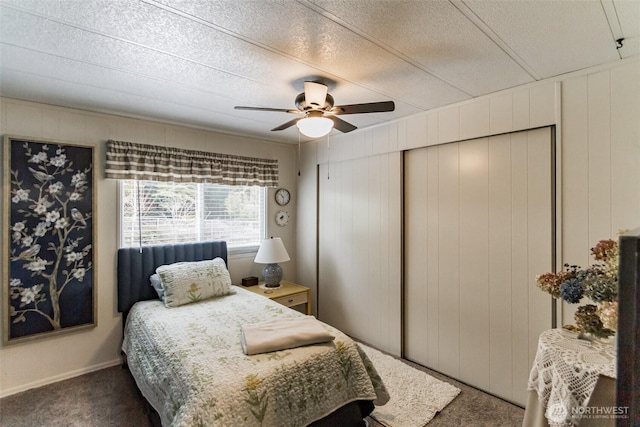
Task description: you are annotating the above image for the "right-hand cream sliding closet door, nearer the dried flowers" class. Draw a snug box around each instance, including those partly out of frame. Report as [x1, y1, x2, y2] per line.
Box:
[404, 128, 554, 405]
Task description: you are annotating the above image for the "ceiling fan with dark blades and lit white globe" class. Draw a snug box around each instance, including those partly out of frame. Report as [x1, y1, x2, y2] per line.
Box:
[235, 82, 395, 138]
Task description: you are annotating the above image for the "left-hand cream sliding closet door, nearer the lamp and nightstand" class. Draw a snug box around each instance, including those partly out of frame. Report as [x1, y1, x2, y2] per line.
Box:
[318, 153, 402, 351]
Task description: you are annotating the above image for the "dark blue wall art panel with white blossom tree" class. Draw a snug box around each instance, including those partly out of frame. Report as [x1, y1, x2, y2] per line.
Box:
[2, 136, 96, 344]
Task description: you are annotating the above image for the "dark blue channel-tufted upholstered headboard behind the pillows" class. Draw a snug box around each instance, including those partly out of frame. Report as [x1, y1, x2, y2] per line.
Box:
[118, 241, 228, 314]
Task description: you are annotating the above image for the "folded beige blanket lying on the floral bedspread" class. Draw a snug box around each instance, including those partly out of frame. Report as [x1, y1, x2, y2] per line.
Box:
[240, 316, 334, 355]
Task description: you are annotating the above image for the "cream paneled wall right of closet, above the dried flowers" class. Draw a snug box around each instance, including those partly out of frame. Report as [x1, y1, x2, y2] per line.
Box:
[561, 61, 640, 324]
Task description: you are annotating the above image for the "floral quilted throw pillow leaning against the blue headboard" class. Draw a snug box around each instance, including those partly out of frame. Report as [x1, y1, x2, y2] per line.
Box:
[156, 258, 235, 307]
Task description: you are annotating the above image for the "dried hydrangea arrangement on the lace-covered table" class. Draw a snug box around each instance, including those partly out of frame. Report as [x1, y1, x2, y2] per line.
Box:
[536, 239, 619, 338]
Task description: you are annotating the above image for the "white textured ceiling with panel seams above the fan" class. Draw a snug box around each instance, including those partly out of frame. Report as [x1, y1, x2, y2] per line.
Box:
[0, 0, 640, 142]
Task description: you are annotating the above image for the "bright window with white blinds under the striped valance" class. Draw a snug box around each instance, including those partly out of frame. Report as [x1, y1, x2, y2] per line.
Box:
[120, 180, 266, 249]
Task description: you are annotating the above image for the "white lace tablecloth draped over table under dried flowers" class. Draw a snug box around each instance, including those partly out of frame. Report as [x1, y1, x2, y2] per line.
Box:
[528, 329, 616, 427]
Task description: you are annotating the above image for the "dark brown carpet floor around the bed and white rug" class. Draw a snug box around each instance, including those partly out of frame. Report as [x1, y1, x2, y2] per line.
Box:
[0, 362, 524, 427]
